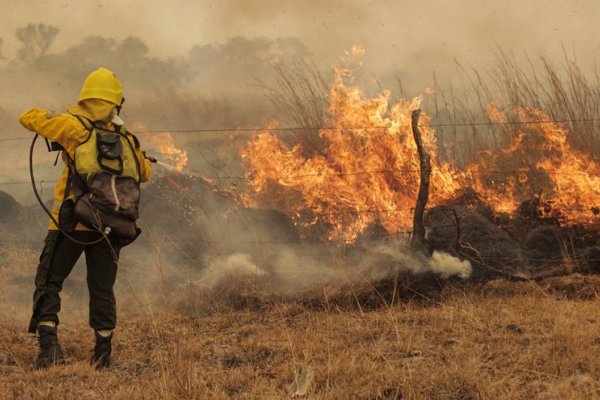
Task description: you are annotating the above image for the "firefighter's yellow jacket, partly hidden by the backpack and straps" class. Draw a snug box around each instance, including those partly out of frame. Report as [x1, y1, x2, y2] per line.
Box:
[19, 99, 152, 231]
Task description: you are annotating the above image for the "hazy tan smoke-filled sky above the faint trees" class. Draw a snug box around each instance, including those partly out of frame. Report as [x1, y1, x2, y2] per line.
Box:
[0, 0, 600, 77]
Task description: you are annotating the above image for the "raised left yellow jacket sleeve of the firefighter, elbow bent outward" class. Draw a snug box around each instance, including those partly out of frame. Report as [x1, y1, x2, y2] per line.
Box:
[19, 108, 83, 149]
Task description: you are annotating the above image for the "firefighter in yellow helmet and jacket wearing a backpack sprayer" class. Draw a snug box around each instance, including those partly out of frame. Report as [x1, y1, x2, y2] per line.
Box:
[20, 68, 151, 369]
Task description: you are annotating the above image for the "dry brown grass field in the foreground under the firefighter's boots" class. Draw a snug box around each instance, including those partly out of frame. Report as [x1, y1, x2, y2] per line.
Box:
[0, 245, 600, 399]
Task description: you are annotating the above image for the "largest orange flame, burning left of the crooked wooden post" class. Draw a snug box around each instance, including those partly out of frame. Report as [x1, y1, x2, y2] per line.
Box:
[242, 69, 459, 241]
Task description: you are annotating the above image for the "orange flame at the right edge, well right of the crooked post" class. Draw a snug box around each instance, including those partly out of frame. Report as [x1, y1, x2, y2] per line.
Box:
[469, 107, 600, 225]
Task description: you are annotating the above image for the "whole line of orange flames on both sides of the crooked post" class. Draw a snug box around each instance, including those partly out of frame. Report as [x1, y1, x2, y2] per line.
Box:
[241, 68, 600, 241]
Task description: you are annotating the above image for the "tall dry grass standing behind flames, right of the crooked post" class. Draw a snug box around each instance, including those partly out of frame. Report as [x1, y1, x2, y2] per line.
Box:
[425, 49, 600, 166]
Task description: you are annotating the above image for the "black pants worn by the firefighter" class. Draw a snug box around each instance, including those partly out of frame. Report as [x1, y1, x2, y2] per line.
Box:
[29, 231, 120, 333]
